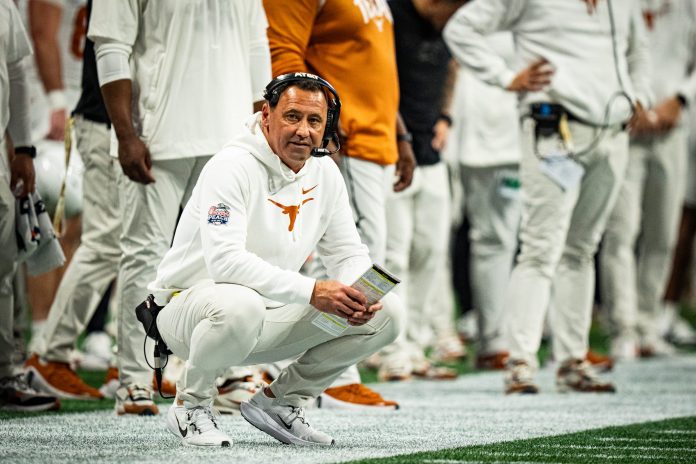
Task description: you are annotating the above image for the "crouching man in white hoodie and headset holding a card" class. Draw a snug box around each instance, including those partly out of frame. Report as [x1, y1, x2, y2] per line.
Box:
[150, 73, 404, 446]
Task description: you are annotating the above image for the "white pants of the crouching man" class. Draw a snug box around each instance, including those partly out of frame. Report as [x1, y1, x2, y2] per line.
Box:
[157, 283, 403, 406]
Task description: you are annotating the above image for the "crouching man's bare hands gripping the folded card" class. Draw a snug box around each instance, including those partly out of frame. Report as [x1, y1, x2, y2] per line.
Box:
[309, 280, 367, 320]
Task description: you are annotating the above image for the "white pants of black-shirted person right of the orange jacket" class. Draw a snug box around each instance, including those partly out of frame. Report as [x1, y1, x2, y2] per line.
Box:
[386, 163, 453, 356]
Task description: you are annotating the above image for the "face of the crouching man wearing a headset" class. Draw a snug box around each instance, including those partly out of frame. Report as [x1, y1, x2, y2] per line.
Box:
[261, 86, 327, 172]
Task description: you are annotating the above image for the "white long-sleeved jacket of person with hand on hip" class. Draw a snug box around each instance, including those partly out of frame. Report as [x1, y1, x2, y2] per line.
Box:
[444, 0, 652, 125]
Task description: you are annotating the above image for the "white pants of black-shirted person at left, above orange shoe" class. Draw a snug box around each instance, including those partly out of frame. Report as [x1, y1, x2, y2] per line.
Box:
[38, 116, 121, 362]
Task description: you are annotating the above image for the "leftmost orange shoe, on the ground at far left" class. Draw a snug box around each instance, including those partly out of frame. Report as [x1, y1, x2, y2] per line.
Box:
[24, 354, 104, 400]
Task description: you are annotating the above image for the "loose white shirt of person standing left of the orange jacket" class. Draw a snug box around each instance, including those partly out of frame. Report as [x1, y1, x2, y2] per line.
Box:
[88, 0, 271, 160]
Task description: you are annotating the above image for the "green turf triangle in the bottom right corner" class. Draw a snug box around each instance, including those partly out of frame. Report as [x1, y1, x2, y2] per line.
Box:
[351, 417, 696, 464]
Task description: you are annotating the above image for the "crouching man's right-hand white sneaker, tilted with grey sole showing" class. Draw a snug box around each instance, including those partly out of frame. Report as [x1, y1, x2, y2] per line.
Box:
[239, 389, 335, 446]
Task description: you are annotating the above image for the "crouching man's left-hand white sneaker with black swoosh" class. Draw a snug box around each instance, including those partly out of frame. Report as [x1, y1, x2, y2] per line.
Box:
[167, 404, 232, 447]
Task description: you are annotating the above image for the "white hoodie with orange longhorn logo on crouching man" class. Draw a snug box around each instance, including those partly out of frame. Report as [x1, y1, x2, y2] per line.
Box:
[149, 113, 372, 307]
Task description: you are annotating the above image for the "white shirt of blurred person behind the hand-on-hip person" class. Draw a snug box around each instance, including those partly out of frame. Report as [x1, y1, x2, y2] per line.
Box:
[446, 32, 520, 167]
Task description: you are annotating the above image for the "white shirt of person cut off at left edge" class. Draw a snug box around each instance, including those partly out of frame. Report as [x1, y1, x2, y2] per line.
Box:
[0, 0, 31, 141]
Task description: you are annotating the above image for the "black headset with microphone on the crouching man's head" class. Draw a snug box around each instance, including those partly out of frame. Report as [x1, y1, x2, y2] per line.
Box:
[263, 72, 341, 157]
